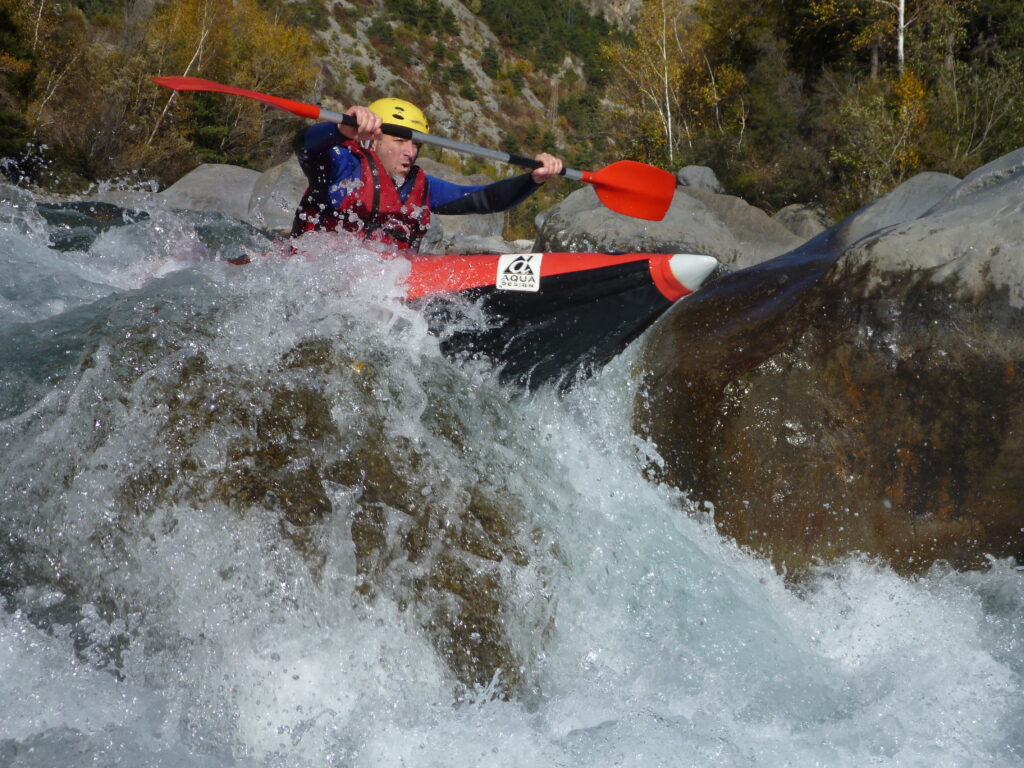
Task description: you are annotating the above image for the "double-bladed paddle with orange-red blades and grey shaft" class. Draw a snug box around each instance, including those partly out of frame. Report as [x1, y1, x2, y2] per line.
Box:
[153, 77, 676, 221]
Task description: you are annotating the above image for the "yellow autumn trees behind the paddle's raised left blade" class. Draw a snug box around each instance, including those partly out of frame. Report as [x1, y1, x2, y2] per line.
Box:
[0, 0, 318, 185]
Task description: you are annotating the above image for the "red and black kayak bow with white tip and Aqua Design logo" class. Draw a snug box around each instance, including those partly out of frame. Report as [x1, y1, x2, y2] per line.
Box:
[406, 253, 718, 389]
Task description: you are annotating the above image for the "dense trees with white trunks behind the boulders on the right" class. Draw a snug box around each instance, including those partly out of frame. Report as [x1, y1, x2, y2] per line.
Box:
[604, 0, 1024, 214]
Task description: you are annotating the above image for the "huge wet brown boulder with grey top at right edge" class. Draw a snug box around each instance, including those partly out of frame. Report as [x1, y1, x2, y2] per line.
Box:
[637, 153, 1024, 573]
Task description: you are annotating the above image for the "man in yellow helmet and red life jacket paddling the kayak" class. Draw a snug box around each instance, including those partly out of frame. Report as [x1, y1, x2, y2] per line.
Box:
[292, 98, 562, 250]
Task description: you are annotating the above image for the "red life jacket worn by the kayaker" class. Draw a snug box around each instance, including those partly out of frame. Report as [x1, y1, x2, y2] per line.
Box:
[292, 141, 430, 251]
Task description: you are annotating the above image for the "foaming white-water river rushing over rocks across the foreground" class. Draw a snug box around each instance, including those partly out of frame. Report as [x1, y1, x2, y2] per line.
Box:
[0, 186, 1024, 768]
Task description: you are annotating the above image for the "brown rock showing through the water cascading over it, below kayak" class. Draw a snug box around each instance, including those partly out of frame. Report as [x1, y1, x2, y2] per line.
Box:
[119, 337, 544, 695]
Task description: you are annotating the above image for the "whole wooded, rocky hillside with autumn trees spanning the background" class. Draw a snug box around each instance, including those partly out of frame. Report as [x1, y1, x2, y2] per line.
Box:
[0, 0, 1024, 228]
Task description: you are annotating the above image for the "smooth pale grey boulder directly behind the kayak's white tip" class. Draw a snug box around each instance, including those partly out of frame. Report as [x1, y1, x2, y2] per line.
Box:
[535, 186, 741, 265]
